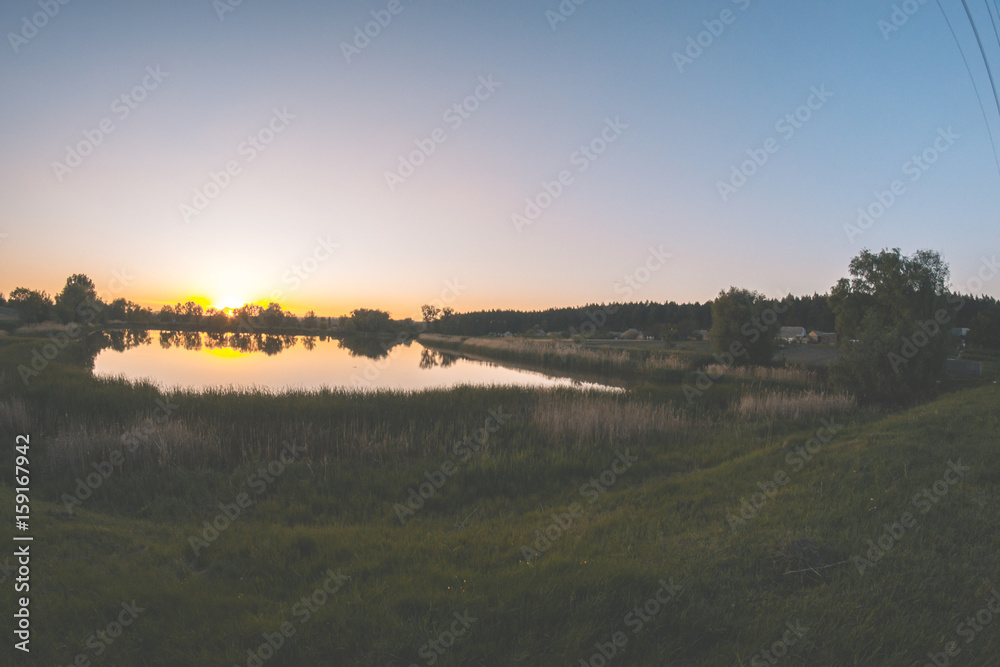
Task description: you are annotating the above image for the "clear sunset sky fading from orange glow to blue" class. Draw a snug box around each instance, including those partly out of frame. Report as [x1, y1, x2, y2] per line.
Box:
[0, 0, 1000, 318]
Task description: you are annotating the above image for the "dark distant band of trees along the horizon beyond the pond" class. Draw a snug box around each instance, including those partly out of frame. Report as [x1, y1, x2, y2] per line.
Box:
[0, 274, 1000, 349]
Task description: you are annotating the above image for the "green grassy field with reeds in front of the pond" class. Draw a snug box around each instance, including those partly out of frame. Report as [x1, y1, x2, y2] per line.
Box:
[0, 337, 1000, 667]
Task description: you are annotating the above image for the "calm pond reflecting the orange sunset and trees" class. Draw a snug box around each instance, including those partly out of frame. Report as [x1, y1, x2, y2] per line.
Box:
[94, 331, 620, 391]
